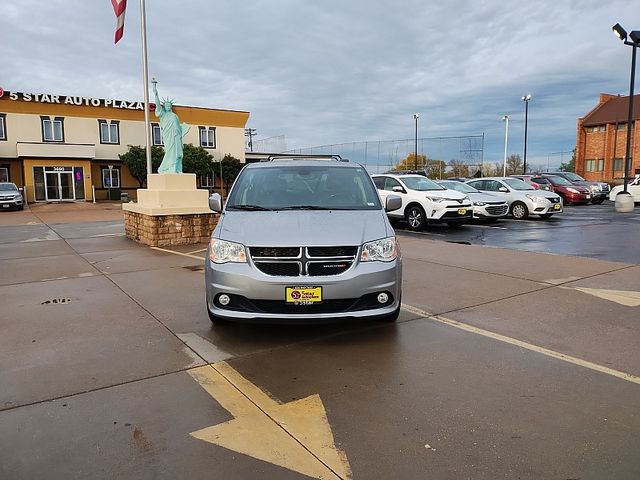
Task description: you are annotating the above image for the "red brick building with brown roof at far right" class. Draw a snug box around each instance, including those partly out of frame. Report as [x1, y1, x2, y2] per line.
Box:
[576, 93, 640, 181]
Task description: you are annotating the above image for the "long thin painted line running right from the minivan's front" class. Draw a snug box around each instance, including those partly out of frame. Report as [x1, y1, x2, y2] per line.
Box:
[402, 303, 640, 385]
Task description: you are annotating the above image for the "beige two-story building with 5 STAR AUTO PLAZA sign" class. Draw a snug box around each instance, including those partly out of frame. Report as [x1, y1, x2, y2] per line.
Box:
[0, 88, 249, 202]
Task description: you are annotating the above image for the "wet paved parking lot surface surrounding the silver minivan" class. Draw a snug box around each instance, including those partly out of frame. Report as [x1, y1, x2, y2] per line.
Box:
[0, 205, 640, 480]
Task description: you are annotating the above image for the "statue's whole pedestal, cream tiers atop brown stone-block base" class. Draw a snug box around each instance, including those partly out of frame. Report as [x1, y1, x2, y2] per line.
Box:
[122, 173, 219, 247]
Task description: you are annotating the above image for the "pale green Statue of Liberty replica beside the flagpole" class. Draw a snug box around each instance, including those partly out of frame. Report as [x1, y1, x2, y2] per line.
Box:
[151, 78, 189, 173]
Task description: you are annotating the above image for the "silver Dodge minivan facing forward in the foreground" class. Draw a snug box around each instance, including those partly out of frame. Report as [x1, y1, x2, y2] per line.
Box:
[205, 158, 402, 324]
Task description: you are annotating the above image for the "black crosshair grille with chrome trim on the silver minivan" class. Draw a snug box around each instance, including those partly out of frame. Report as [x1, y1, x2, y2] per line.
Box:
[249, 246, 358, 277]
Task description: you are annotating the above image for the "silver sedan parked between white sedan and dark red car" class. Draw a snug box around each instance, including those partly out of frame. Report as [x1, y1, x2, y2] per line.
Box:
[466, 177, 562, 220]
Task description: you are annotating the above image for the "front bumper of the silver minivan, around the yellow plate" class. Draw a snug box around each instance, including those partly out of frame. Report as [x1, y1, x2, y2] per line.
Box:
[205, 258, 402, 323]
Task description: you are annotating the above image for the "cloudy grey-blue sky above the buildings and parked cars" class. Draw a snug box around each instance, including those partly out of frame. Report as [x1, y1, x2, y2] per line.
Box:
[0, 0, 640, 166]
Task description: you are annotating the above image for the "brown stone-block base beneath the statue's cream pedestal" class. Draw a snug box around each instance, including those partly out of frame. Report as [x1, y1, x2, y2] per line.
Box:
[124, 210, 220, 247]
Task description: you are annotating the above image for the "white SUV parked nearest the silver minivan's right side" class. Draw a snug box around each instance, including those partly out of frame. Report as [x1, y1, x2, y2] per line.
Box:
[372, 173, 473, 230]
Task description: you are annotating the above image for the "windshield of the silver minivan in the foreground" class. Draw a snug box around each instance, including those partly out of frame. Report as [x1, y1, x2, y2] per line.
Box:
[226, 165, 382, 211]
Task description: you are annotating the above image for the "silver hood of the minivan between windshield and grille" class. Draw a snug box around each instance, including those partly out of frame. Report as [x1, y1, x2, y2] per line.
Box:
[214, 210, 393, 247]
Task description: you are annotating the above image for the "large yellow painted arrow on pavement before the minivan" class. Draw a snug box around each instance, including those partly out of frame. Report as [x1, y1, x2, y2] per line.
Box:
[189, 362, 351, 480]
